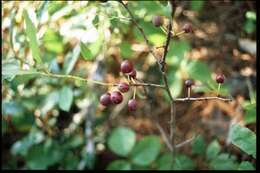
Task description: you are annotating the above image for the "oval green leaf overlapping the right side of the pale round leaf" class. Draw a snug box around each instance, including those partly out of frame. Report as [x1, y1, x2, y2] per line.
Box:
[130, 136, 161, 166]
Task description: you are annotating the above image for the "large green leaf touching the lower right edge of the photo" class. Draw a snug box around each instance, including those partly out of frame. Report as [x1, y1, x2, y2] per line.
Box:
[228, 124, 256, 158]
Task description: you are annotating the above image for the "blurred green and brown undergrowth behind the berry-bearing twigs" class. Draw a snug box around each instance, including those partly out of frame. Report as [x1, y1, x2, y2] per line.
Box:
[1, 0, 256, 170]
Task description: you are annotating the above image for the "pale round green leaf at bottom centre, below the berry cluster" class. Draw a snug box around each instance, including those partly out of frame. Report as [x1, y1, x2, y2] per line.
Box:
[108, 127, 136, 156]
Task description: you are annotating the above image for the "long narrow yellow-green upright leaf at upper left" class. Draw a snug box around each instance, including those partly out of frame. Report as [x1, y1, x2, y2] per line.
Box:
[23, 10, 42, 63]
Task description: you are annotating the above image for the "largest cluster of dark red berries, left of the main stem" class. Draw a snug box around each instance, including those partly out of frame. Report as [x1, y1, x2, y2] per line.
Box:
[99, 60, 137, 111]
